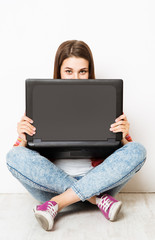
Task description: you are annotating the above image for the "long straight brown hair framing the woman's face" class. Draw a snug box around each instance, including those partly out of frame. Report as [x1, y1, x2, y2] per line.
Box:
[53, 40, 95, 79]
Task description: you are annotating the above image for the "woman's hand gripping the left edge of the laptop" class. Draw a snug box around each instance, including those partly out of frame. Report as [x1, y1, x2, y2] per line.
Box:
[17, 113, 36, 142]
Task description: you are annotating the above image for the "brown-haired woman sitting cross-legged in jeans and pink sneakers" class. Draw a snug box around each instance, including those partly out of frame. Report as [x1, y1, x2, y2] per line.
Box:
[7, 40, 146, 230]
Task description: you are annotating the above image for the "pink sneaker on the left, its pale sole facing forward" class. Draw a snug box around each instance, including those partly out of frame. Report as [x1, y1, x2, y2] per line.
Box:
[33, 201, 58, 231]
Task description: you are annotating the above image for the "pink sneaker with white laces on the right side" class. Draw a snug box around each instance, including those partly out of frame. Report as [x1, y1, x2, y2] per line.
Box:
[97, 194, 122, 221]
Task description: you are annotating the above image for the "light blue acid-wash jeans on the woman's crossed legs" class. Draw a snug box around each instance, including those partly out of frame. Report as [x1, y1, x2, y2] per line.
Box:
[7, 142, 146, 202]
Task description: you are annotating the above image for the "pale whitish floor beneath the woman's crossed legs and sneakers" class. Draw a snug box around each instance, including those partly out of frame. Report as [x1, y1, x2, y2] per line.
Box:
[0, 193, 155, 240]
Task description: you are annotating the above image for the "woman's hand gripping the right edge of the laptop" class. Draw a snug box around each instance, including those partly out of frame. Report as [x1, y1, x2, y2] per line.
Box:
[110, 114, 130, 138]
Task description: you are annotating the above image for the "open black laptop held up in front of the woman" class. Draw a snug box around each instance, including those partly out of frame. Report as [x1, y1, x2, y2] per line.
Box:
[25, 79, 123, 159]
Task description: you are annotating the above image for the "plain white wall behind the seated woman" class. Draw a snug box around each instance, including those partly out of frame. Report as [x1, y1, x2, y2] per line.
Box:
[0, 0, 155, 192]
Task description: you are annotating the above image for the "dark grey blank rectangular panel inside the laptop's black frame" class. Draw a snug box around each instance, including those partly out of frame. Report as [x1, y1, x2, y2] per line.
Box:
[32, 84, 116, 141]
